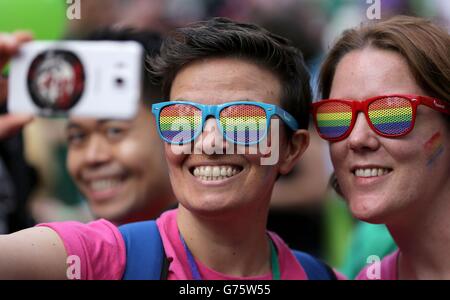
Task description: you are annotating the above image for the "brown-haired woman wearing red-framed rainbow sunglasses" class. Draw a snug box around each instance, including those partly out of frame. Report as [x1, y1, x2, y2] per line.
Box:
[313, 16, 450, 279]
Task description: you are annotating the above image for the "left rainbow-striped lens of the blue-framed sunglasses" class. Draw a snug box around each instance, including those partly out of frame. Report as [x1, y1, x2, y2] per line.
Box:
[159, 104, 202, 144]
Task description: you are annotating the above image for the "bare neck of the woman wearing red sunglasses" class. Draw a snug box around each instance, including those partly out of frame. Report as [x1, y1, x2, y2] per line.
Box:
[388, 188, 450, 279]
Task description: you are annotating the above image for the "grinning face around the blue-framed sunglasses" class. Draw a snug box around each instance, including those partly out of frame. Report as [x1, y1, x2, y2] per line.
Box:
[165, 58, 306, 216]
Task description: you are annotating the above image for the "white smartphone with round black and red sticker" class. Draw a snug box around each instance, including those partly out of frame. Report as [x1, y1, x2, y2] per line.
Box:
[8, 41, 144, 119]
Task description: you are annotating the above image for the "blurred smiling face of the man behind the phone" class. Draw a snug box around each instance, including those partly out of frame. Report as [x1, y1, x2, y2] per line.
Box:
[67, 105, 170, 223]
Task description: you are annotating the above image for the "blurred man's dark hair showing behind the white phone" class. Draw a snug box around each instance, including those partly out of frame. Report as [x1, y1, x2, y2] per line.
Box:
[86, 27, 162, 104]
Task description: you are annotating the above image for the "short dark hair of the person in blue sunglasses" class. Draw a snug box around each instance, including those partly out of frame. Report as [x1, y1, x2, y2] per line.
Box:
[149, 18, 311, 129]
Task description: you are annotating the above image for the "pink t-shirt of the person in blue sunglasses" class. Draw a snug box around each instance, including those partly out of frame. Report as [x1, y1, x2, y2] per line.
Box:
[38, 209, 332, 280]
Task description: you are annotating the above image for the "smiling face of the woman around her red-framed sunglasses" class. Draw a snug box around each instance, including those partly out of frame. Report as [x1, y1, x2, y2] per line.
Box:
[330, 47, 450, 223]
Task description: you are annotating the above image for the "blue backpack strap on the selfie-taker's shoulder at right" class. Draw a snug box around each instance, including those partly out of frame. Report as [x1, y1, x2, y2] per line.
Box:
[292, 250, 337, 280]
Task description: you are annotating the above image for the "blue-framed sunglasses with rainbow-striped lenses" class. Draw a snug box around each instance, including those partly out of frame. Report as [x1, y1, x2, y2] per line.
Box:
[152, 101, 298, 146]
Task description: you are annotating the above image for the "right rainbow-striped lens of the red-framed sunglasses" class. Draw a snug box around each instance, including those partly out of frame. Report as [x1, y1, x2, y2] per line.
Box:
[367, 97, 413, 135]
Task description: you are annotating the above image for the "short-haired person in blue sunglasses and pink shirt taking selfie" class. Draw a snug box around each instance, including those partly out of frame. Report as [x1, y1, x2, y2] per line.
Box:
[0, 18, 342, 280]
